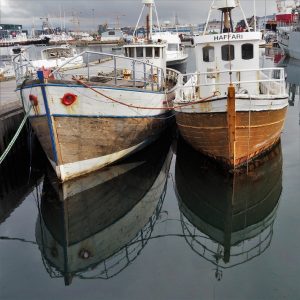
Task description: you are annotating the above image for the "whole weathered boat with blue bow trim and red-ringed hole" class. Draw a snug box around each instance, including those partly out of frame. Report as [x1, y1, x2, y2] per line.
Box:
[14, 4, 177, 181]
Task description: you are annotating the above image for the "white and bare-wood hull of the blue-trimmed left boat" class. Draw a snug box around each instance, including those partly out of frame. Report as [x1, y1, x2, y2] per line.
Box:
[21, 83, 170, 181]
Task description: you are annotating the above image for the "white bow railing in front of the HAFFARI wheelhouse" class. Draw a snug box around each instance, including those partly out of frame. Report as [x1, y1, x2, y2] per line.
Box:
[176, 68, 286, 101]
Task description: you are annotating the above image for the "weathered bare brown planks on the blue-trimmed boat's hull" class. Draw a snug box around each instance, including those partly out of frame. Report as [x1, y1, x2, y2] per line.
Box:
[35, 117, 166, 164]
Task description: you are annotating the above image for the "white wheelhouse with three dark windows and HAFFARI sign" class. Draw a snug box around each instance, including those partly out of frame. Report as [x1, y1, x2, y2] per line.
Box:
[194, 32, 261, 94]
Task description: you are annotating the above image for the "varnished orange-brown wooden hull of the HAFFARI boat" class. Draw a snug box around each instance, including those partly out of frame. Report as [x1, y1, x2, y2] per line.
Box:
[176, 99, 287, 169]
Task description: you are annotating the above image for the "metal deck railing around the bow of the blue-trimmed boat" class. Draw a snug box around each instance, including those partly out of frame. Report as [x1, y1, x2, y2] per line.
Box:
[14, 51, 170, 91]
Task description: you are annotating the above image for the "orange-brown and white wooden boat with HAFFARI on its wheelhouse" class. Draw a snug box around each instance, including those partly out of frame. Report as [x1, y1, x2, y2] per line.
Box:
[175, 0, 288, 169]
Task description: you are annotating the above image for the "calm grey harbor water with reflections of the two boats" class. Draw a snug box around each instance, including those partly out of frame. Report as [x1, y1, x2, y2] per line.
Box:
[0, 48, 300, 300]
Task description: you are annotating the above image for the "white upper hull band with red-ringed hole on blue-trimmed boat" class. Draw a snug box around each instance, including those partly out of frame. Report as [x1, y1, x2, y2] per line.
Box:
[23, 83, 167, 117]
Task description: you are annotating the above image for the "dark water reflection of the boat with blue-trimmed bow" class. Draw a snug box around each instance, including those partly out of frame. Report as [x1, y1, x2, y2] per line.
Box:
[36, 136, 172, 285]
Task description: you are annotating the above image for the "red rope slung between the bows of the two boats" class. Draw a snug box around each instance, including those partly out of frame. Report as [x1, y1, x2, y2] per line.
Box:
[72, 76, 218, 110]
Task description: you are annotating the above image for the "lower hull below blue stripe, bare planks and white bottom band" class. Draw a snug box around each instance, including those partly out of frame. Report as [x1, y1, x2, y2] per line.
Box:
[31, 116, 167, 181]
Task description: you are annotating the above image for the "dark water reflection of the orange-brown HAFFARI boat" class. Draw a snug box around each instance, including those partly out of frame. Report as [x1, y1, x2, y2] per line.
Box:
[175, 142, 282, 280]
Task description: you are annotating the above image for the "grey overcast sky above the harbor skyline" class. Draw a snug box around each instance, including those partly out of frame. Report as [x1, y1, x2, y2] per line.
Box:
[0, 0, 276, 30]
